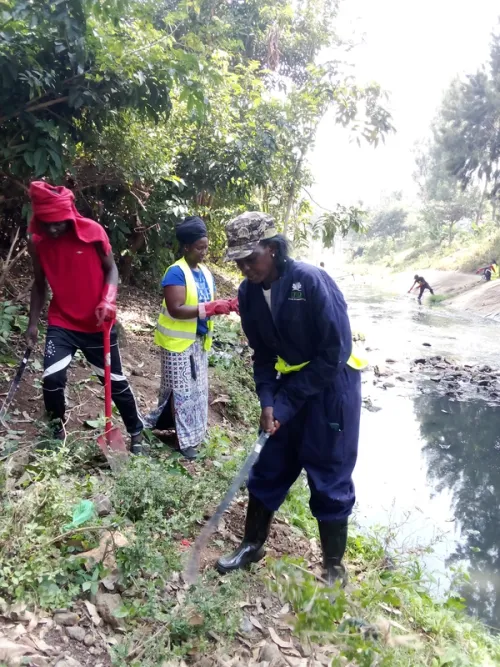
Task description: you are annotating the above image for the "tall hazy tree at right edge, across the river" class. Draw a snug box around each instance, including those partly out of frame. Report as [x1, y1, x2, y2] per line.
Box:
[417, 26, 500, 241]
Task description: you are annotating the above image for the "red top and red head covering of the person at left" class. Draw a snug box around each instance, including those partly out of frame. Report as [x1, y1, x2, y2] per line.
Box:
[28, 181, 111, 333]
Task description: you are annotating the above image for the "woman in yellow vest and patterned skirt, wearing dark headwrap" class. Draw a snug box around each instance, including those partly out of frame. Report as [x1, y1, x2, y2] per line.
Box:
[145, 216, 238, 459]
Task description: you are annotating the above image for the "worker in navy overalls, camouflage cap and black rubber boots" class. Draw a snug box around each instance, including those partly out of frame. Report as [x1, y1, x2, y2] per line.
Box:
[217, 212, 361, 583]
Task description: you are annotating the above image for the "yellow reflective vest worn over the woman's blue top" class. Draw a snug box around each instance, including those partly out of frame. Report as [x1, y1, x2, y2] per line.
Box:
[155, 258, 214, 352]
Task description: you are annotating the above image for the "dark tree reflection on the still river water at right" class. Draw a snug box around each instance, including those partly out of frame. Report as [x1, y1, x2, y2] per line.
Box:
[414, 395, 500, 627]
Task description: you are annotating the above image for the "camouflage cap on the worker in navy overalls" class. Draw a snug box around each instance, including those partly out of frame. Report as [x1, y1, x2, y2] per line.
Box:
[226, 211, 278, 262]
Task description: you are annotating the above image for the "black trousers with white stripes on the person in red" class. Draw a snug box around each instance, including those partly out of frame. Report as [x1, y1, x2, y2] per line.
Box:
[43, 326, 144, 435]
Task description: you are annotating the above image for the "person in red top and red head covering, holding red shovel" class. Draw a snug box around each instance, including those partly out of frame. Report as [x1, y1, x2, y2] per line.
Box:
[26, 181, 144, 454]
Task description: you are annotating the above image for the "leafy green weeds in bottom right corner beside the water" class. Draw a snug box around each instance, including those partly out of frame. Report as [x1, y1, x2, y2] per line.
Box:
[269, 548, 500, 667]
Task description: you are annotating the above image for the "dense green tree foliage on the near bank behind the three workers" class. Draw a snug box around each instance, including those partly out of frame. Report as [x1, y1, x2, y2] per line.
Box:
[0, 0, 392, 279]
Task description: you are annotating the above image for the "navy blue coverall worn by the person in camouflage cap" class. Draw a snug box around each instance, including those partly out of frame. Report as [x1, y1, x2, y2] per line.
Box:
[239, 260, 361, 521]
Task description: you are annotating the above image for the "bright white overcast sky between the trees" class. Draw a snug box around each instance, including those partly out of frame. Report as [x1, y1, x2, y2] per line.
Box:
[310, 0, 500, 208]
